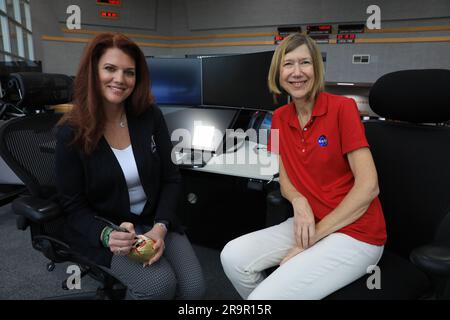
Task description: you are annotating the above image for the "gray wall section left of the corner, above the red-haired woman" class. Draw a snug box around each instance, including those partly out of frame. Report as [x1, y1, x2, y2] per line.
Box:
[30, 0, 171, 75]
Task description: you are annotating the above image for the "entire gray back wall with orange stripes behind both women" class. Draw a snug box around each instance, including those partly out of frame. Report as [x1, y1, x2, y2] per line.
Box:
[31, 0, 450, 82]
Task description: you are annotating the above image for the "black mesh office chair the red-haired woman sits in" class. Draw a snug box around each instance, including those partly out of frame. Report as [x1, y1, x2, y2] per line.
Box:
[0, 77, 126, 299]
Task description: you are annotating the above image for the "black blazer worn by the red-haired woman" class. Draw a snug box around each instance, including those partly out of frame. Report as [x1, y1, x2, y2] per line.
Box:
[56, 105, 182, 267]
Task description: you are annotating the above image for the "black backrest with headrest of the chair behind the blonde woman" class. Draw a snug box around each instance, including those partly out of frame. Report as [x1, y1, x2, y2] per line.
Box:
[365, 70, 450, 257]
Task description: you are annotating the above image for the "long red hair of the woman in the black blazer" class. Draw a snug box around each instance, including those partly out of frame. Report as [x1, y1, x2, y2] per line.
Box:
[59, 33, 154, 154]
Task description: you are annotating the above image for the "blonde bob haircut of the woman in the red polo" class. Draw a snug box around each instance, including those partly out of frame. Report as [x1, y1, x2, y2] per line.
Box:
[267, 33, 324, 100]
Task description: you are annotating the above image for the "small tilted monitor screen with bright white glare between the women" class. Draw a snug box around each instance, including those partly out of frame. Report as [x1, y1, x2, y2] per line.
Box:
[161, 106, 238, 153]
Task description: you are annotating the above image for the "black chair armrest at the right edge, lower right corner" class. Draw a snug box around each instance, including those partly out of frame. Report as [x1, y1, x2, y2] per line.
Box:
[410, 245, 450, 277]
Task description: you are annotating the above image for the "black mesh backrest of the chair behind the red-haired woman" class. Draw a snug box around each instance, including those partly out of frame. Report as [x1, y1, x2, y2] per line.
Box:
[0, 114, 61, 198]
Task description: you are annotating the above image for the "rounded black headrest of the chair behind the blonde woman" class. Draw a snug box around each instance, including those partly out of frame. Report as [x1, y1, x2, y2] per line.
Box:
[369, 69, 450, 123]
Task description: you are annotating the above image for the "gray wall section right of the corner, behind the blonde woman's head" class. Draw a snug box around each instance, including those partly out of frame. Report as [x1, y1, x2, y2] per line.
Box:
[172, 0, 450, 82]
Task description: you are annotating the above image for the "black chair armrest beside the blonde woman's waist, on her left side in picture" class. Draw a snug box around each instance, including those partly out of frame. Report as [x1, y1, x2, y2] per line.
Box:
[266, 189, 293, 227]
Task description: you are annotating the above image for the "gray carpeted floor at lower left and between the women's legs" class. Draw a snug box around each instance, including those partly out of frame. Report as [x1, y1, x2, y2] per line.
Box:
[0, 205, 240, 300]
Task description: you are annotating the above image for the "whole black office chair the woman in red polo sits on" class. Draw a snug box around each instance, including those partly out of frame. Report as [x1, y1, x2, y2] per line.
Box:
[267, 70, 450, 299]
